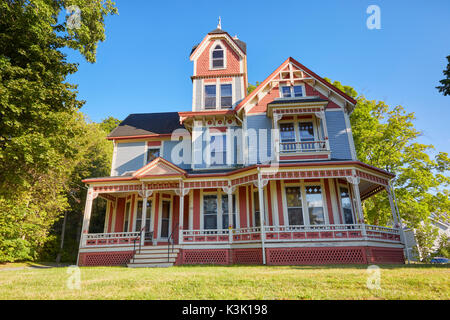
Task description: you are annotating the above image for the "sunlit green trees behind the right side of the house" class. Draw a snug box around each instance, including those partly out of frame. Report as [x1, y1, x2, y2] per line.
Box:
[327, 79, 450, 227]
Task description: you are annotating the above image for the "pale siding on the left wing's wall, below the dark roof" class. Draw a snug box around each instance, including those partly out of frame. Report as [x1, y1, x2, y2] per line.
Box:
[113, 142, 145, 176]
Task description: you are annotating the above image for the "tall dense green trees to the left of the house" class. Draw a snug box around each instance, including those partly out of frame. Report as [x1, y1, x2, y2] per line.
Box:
[0, 0, 117, 261]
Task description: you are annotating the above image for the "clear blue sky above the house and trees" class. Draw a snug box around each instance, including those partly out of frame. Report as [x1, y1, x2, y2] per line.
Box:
[69, 0, 450, 153]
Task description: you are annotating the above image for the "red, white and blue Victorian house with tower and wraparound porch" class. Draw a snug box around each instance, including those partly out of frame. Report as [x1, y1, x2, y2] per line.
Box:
[78, 24, 404, 266]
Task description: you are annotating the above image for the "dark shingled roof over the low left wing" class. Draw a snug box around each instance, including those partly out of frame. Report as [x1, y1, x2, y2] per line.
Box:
[108, 112, 184, 137]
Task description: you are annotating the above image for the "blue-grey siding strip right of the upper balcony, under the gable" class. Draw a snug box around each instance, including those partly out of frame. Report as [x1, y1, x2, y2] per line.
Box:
[325, 111, 352, 160]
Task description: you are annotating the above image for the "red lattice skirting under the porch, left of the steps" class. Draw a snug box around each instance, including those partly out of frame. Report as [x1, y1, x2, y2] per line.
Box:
[78, 251, 133, 266]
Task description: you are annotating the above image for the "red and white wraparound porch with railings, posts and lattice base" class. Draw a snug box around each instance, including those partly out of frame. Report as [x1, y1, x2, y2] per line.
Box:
[79, 161, 403, 265]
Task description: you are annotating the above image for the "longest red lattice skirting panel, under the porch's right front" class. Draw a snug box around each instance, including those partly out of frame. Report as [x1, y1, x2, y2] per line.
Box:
[266, 247, 367, 265]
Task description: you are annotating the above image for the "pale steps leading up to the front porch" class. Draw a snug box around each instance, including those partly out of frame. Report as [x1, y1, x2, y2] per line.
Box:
[128, 245, 179, 268]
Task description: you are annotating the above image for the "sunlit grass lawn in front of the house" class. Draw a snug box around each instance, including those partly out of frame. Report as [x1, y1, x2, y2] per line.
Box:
[0, 265, 450, 300]
